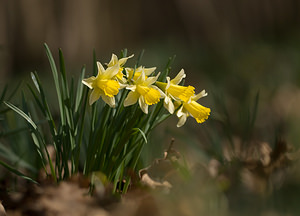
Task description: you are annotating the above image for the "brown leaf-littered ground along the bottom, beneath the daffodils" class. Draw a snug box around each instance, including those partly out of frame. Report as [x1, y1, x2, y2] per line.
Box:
[0, 138, 299, 216]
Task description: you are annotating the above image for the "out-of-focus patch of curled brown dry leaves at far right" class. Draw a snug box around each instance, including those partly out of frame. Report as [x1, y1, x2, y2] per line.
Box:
[219, 138, 297, 194]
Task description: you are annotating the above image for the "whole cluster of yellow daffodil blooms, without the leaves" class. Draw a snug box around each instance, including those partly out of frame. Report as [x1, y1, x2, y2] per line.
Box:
[82, 54, 210, 127]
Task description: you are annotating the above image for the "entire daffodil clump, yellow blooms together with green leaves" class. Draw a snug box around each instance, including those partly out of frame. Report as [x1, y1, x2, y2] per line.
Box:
[4, 44, 210, 192]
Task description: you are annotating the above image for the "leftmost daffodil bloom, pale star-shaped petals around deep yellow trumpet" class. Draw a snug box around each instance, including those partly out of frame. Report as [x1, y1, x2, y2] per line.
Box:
[82, 62, 122, 107]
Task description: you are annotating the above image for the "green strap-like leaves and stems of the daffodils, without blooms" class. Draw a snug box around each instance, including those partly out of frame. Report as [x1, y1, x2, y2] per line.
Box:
[1, 44, 173, 191]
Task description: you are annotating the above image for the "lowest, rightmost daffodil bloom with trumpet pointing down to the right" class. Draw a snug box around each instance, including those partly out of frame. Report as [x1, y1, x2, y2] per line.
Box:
[177, 90, 210, 127]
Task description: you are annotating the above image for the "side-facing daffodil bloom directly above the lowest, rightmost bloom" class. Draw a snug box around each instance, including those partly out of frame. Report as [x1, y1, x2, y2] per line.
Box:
[156, 69, 195, 114]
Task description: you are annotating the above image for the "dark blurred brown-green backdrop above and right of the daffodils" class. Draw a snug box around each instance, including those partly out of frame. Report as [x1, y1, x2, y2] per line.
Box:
[0, 0, 300, 215]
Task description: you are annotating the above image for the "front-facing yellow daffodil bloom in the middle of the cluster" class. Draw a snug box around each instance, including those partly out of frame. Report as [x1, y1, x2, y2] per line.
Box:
[124, 71, 164, 114]
